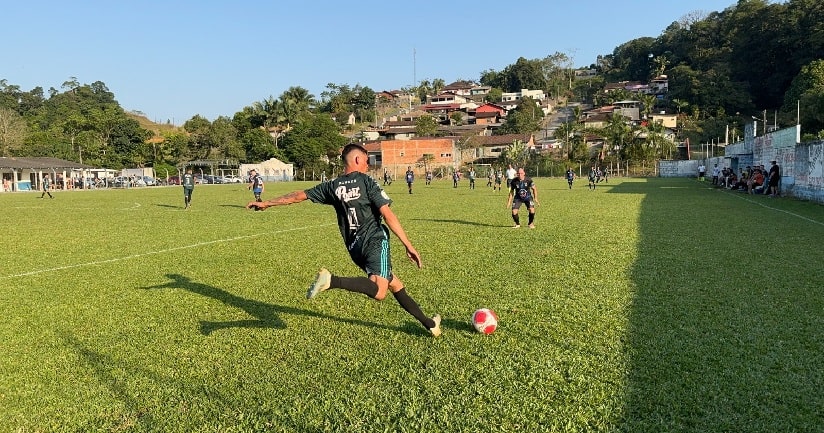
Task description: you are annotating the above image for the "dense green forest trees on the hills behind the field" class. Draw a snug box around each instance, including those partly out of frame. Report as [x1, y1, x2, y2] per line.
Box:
[0, 0, 824, 169]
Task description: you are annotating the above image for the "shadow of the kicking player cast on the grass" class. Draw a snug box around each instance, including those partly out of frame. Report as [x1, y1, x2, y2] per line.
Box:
[142, 274, 412, 335]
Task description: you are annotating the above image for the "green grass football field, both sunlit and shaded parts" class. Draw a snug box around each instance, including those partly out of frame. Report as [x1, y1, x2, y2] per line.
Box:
[0, 179, 824, 432]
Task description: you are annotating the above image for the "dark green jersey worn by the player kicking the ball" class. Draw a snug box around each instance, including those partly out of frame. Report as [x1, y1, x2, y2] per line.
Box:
[304, 172, 392, 249]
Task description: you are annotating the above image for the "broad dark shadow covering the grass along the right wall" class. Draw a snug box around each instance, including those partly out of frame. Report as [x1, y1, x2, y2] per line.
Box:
[610, 179, 824, 432]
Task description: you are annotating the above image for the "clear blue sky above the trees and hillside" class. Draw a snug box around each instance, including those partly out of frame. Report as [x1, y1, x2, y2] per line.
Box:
[0, 0, 735, 125]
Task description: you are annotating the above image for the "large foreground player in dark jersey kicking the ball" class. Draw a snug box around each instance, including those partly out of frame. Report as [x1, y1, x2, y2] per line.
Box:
[246, 144, 441, 337]
